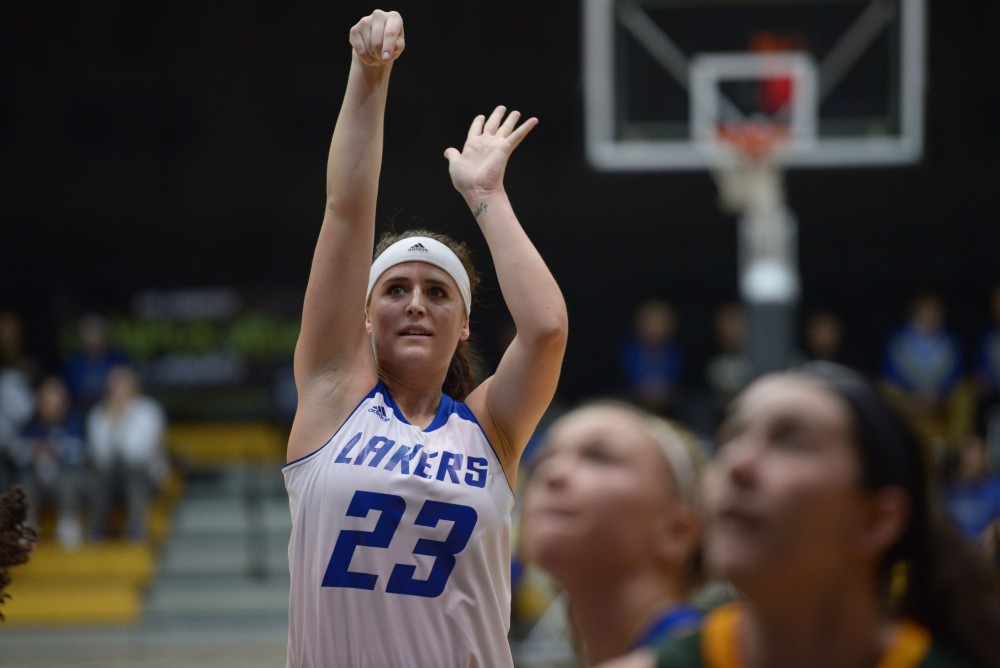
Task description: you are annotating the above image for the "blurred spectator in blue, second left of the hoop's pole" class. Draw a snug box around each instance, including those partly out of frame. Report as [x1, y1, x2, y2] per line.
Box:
[621, 299, 681, 416]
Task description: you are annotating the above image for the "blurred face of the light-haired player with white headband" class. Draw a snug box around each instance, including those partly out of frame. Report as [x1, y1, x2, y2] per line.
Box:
[521, 406, 678, 585]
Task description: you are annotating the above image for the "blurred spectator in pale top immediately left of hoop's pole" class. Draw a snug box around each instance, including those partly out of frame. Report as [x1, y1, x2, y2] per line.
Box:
[705, 302, 754, 430]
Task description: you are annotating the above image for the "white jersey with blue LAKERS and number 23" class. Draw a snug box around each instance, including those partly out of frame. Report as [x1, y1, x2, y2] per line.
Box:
[283, 382, 514, 668]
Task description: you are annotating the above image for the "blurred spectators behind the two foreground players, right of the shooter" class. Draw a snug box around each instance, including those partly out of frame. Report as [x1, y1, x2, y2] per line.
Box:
[618, 287, 1000, 556]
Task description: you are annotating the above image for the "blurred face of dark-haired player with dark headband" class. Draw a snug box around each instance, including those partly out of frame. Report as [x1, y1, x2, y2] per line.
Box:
[703, 375, 866, 593]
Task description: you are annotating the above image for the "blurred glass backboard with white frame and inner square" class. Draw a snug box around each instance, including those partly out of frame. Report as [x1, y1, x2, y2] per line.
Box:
[583, 0, 926, 170]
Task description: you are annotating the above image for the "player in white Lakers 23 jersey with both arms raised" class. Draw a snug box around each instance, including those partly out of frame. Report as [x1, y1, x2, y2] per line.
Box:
[284, 11, 567, 667]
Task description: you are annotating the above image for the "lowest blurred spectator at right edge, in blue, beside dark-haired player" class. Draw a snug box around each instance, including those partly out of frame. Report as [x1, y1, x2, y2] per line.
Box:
[945, 434, 1000, 541]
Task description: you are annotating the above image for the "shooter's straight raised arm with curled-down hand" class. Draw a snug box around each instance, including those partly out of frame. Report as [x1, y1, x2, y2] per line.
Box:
[289, 11, 404, 455]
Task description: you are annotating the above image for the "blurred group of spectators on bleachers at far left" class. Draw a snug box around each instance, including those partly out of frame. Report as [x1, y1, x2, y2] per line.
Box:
[0, 311, 170, 548]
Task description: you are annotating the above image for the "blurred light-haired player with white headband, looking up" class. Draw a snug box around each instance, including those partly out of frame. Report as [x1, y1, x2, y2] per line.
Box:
[521, 403, 701, 665]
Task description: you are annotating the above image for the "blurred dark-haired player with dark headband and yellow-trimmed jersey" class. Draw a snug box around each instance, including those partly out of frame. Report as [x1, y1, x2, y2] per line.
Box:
[609, 363, 1000, 668]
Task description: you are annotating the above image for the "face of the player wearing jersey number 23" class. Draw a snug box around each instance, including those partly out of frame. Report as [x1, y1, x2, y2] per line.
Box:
[366, 262, 469, 370]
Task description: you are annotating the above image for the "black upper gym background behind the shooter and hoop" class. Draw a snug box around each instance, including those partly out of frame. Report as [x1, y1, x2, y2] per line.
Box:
[0, 0, 1000, 408]
